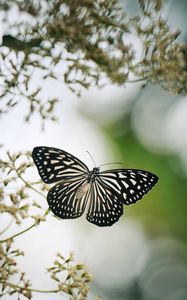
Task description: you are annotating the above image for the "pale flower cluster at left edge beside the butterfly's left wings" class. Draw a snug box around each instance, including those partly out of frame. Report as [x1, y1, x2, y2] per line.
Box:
[0, 151, 47, 225]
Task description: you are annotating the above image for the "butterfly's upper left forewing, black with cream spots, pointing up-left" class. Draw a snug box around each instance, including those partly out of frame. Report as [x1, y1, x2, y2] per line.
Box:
[32, 146, 89, 183]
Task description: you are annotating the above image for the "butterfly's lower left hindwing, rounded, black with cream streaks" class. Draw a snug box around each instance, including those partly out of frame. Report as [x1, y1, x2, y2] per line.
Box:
[47, 178, 87, 219]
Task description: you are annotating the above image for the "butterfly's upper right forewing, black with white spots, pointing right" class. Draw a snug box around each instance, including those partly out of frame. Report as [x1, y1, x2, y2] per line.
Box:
[98, 169, 158, 205]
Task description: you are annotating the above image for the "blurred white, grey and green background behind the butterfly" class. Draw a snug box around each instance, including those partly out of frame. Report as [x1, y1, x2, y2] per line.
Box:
[0, 0, 187, 300]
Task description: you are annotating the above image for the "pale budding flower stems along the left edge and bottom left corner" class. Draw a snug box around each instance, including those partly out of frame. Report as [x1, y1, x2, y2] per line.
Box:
[0, 152, 99, 300]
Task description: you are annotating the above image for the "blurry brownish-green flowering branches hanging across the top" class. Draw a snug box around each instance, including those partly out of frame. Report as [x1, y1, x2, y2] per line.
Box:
[0, 0, 187, 122]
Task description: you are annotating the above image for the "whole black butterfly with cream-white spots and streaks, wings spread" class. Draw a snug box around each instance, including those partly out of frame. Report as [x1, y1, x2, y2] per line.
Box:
[32, 146, 158, 226]
